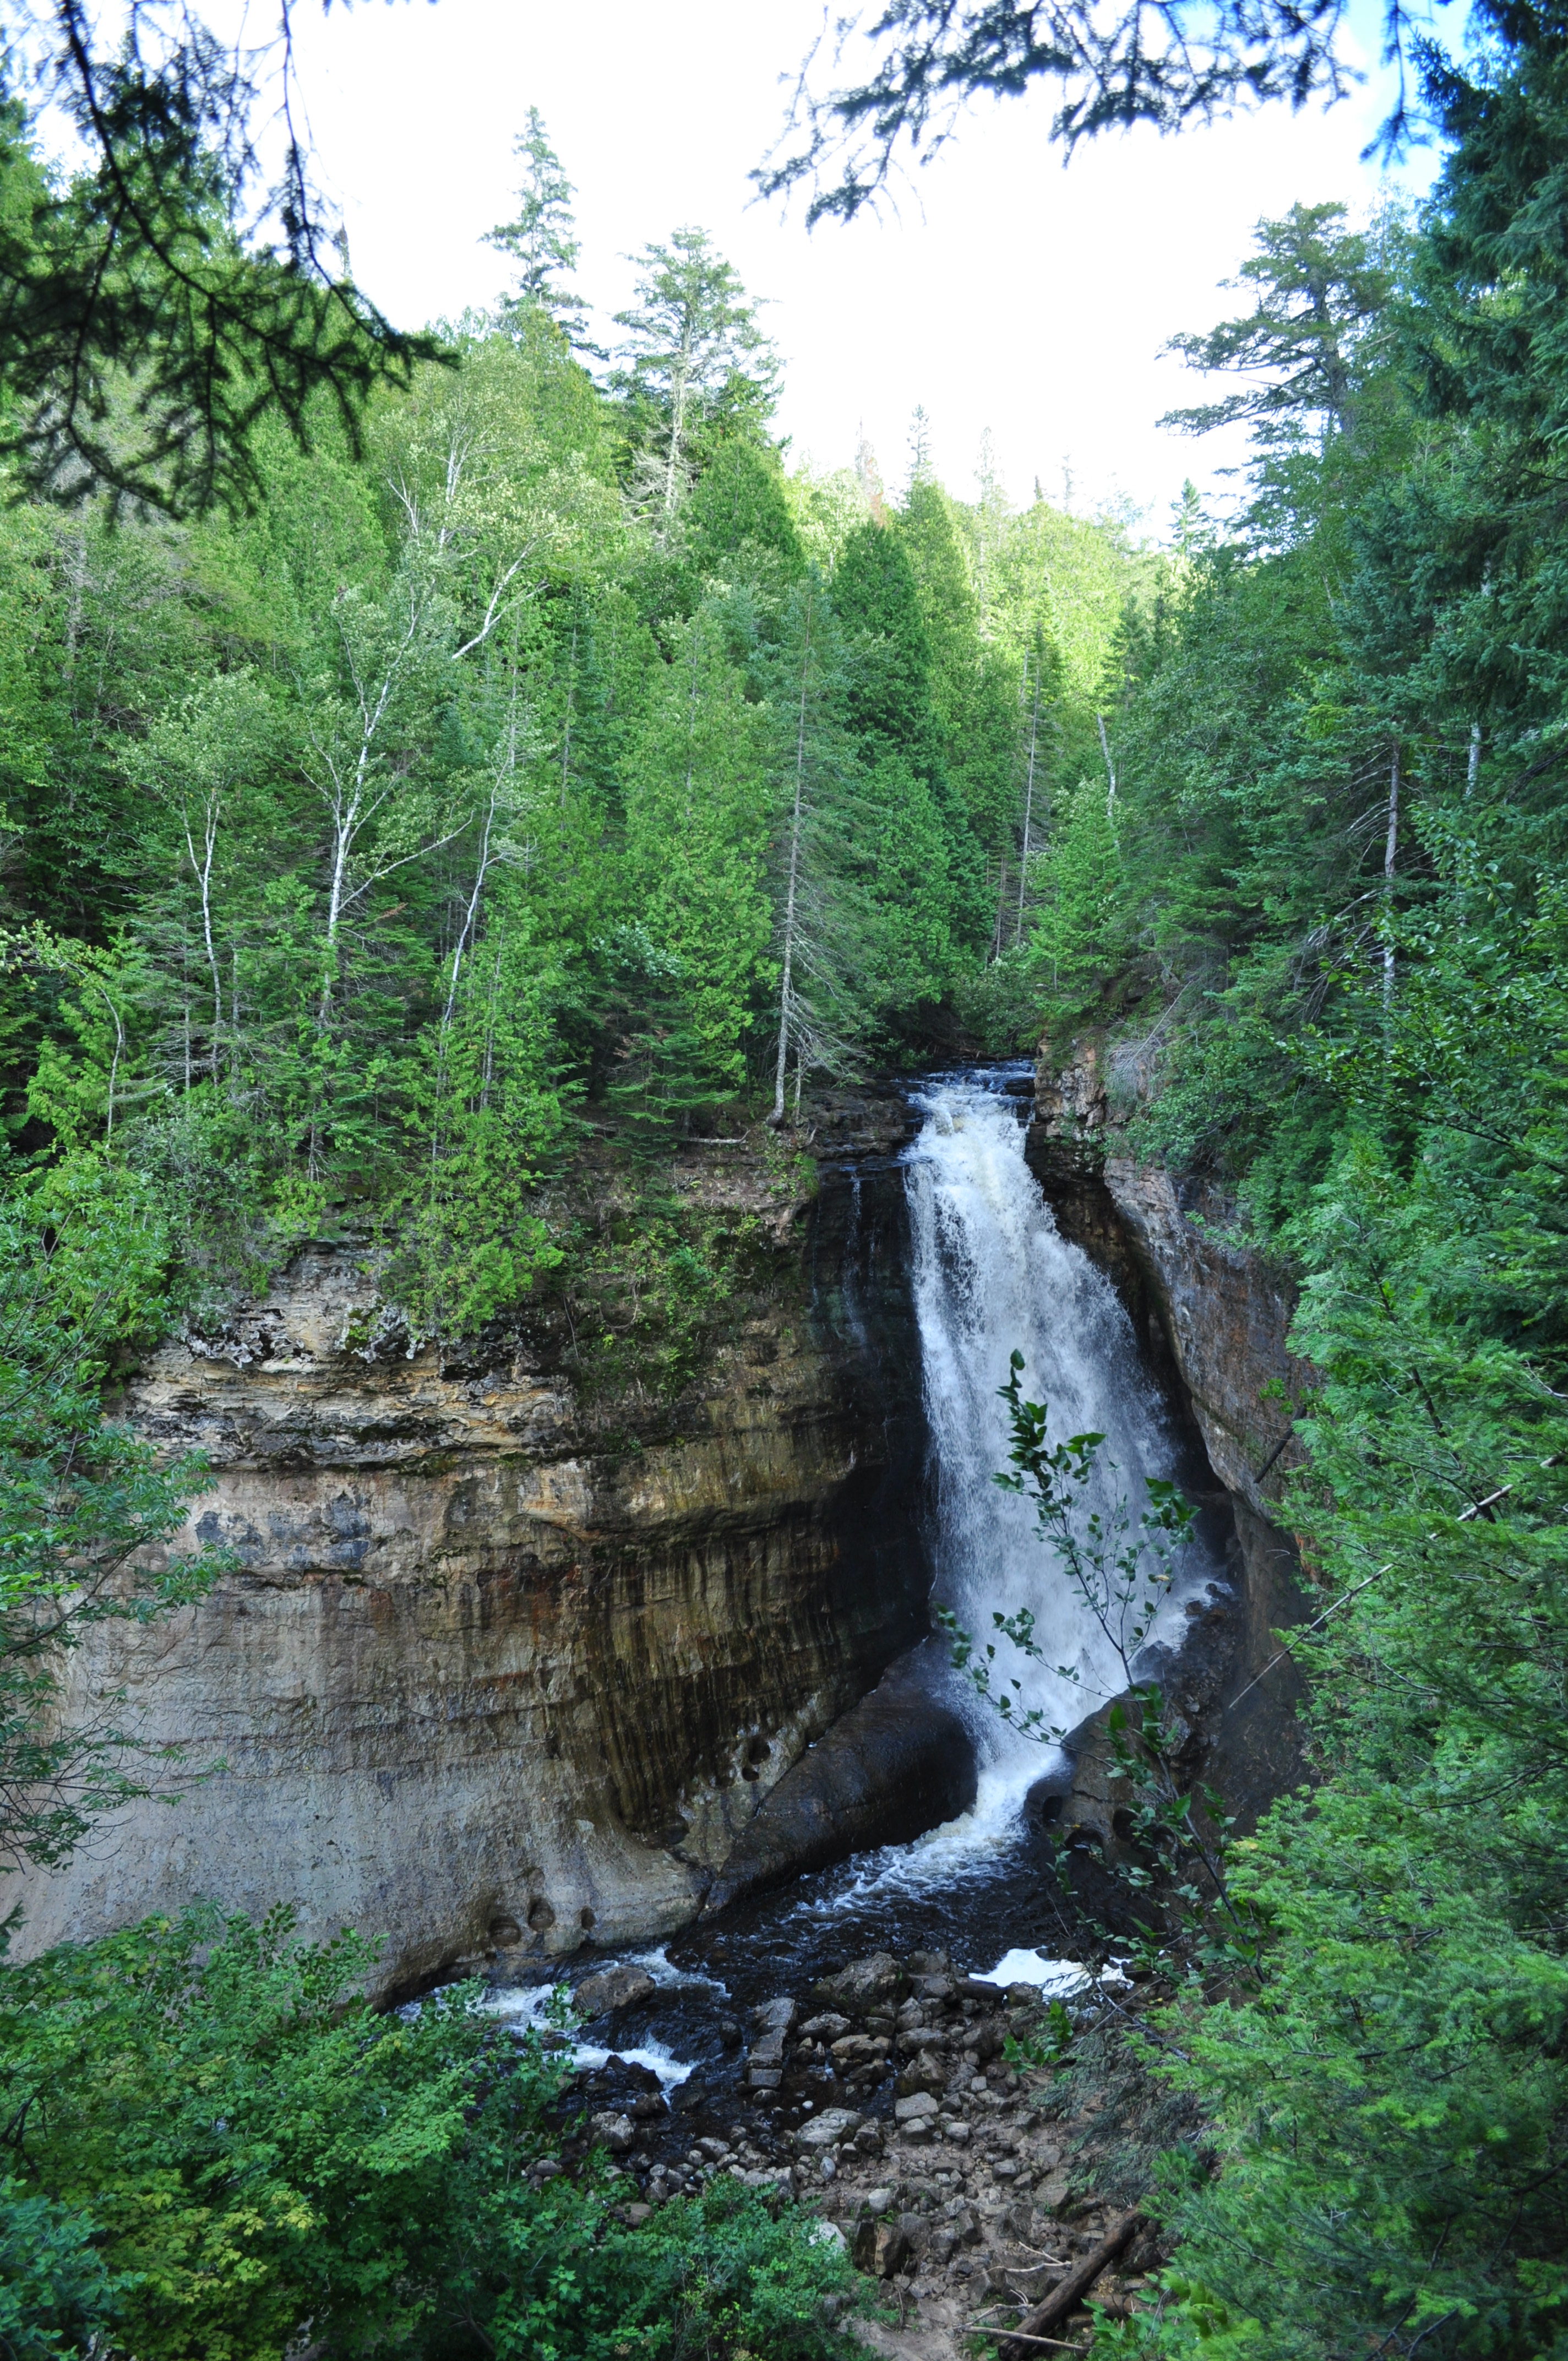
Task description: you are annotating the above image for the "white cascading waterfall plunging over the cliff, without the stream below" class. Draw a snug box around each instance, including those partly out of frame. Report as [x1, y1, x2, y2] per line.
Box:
[907, 1074, 1216, 1837]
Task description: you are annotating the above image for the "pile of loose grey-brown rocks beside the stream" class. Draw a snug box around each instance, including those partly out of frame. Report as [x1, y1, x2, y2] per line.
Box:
[550, 1952, 1157, 2356]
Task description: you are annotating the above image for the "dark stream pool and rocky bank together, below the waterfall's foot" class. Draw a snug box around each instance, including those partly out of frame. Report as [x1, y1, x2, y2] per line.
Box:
[472, 1818, 1180, 2361]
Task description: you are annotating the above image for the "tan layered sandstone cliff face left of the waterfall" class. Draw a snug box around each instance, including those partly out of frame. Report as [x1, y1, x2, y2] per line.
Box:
[12, 1128, 928, 1990]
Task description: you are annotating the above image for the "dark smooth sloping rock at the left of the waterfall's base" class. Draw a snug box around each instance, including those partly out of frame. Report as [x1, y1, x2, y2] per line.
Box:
[706, 1657, 975, 1915]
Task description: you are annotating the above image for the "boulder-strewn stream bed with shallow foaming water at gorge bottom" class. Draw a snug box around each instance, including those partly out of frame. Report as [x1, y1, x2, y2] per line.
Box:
[496, 1936, 1162, 2361]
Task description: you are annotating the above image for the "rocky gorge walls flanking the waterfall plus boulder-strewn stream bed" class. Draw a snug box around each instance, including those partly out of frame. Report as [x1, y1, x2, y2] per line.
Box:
[24, 1048, 1306, 2323]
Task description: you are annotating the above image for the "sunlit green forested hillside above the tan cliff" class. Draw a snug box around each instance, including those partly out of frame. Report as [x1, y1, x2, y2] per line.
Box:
[0, 106, 1145, 1334]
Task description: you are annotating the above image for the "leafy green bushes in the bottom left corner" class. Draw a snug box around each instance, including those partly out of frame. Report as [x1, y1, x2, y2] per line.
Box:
[0, 1910, 850, 2361]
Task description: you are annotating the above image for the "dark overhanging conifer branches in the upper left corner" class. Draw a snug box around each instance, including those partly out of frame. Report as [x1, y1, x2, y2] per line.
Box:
[0, 39, 439, 515]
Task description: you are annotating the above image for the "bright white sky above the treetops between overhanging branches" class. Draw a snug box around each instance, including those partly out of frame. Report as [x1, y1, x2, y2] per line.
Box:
[266, 0, 1434, 531]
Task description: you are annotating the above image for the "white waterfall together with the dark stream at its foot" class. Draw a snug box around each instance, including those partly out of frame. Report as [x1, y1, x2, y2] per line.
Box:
[491, 1063, 1223, 2156]
